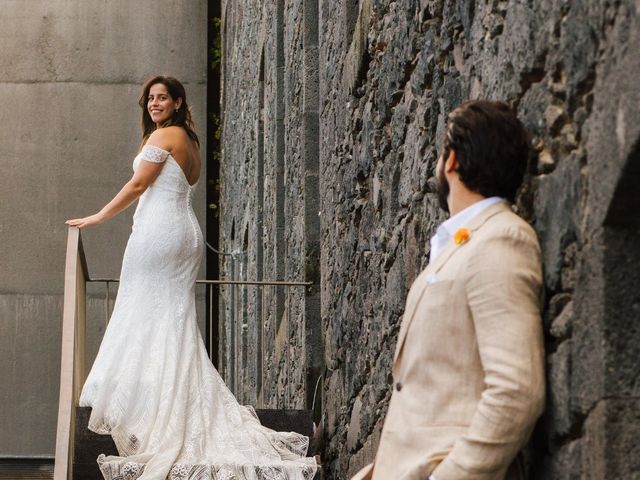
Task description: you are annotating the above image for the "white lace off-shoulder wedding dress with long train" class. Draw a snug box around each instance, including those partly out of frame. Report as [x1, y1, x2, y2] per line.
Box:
[80, 145, 317, 480]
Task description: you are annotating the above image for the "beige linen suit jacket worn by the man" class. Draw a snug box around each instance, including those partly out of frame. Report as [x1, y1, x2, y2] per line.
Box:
[354, 202, 544, 480]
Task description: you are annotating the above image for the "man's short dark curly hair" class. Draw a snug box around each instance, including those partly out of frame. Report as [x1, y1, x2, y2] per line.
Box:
[443, 100, 530, 202]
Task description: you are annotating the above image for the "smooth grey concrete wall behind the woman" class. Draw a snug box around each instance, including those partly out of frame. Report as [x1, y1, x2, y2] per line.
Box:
[0, 0, 207, 456]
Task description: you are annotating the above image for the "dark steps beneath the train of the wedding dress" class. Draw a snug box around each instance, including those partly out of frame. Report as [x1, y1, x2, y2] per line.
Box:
[73, 407, 322, 480]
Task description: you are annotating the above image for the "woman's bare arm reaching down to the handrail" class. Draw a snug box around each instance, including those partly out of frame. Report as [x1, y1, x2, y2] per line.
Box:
[65, 162, 164, 228]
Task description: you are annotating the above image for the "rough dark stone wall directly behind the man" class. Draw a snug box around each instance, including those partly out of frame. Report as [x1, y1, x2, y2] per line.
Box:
[320, 0, 640, 478]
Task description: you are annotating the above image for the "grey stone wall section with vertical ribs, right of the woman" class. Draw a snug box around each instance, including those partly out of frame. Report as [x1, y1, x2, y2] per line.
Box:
[220, 0, 321, 408]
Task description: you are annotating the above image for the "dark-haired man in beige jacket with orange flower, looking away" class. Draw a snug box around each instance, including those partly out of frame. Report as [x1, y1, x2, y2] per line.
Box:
[352, 101, 544, 480]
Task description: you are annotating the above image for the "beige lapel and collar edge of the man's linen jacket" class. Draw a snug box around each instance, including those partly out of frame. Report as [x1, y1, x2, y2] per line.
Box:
[393, 202, 510, 369]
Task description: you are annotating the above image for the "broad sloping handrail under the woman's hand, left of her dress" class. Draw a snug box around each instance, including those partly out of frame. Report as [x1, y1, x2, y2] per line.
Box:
[53, 227, 89, 480]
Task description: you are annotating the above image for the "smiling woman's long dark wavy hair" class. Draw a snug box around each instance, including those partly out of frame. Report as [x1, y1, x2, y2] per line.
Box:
[138, 75, 200, 147]
